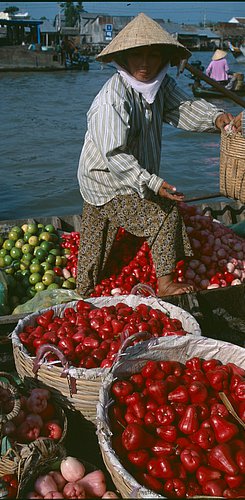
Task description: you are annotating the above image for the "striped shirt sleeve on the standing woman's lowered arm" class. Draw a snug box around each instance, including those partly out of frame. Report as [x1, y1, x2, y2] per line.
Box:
[90, 103, 163, 198]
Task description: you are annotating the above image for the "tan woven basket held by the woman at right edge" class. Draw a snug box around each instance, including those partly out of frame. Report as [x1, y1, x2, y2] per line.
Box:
[220, 130, 245, 203]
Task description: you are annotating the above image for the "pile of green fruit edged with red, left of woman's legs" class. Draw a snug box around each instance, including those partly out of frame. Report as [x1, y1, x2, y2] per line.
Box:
[0, 226, 79, 314]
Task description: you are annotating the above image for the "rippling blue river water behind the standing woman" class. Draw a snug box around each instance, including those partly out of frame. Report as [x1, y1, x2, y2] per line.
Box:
[0, 52, 244, 220]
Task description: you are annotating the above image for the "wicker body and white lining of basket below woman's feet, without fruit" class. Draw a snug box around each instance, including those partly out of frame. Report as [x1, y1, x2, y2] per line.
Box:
[12, 295, 201, 423]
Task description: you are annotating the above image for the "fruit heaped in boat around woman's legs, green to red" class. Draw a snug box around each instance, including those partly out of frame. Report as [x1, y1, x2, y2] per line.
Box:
[0, 203, 245, 314]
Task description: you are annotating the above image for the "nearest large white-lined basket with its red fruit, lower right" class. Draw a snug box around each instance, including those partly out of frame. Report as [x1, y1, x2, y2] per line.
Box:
[97, 335, 245, 498]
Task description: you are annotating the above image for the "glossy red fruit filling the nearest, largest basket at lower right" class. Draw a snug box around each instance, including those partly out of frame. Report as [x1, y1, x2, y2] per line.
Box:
[108, 356, 245, 498]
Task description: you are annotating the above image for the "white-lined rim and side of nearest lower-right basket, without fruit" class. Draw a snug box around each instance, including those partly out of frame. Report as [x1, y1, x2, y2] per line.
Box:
[97, 335, 245, 498]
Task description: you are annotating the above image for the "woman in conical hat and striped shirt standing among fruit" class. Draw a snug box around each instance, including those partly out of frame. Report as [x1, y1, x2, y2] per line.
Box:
[77, 14, 241, 297]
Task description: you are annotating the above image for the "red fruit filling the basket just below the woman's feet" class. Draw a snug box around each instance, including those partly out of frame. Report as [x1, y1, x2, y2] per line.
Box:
[18, 300, 187, 369]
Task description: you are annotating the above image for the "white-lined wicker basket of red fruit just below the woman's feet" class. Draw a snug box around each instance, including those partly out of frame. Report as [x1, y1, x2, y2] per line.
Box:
[12, 295, 201, 423]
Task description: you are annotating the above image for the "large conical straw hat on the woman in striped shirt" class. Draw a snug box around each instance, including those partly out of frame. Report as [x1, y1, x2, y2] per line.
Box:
[96, 13, 191, 64]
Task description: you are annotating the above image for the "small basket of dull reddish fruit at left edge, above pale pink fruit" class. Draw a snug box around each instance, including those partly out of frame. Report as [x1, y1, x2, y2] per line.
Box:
[0, 372, 67, 481]
